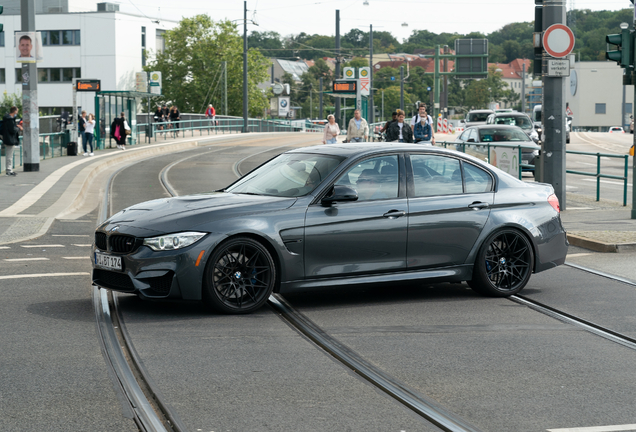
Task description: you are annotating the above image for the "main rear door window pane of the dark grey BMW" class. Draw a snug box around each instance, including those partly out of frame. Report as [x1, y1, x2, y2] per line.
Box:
[411, 154, 463, 197]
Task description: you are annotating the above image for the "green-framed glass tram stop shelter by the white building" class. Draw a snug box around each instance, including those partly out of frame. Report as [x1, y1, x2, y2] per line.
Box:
[94, 90, 161, 149]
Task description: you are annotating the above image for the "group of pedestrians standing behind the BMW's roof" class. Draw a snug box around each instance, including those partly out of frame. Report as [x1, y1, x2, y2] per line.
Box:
[322, 104, 435, 145]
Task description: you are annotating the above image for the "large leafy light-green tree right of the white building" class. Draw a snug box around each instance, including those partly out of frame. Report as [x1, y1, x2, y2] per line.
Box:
[144, 15, 269, 116]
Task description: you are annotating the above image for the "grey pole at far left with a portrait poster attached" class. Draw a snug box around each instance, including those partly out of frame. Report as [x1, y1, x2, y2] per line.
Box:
[21, 0, 39, 171]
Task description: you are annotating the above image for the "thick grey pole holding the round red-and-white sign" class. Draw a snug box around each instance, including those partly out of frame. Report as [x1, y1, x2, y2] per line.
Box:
[540, 0, 569, 210]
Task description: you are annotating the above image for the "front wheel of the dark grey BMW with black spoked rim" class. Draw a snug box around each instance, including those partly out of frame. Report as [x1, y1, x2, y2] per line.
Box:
[203, 237, 276, 314]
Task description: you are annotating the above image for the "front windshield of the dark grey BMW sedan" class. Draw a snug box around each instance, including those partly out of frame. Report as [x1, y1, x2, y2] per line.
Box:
[225, 153, 345, 197]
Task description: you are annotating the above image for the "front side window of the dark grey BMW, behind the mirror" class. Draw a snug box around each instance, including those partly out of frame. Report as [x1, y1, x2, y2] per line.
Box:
[335, 155, 400, 201]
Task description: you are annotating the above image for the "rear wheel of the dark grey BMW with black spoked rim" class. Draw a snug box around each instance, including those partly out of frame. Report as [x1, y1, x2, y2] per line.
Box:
[468, 229, 534, 297]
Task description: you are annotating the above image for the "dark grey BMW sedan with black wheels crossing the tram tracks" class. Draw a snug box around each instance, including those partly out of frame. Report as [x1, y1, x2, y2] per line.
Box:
[92, 143, 568, 313]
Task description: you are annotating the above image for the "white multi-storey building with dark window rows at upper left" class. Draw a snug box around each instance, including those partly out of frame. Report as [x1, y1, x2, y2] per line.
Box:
[0, 0, 178, 115]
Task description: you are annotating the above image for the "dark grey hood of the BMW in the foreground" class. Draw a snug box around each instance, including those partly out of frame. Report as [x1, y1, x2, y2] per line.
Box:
[98, 192, 296, 237]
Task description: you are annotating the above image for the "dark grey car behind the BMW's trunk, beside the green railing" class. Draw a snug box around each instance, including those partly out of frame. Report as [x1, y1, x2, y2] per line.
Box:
[455, 124, 541, 174]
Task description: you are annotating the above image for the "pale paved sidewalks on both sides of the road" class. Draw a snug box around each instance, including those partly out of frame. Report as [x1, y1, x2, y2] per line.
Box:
[0, 134, 636, 252]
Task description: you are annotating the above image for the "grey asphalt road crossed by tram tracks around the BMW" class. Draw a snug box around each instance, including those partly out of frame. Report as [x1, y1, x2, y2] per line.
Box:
[0, 135, 636, 432]
